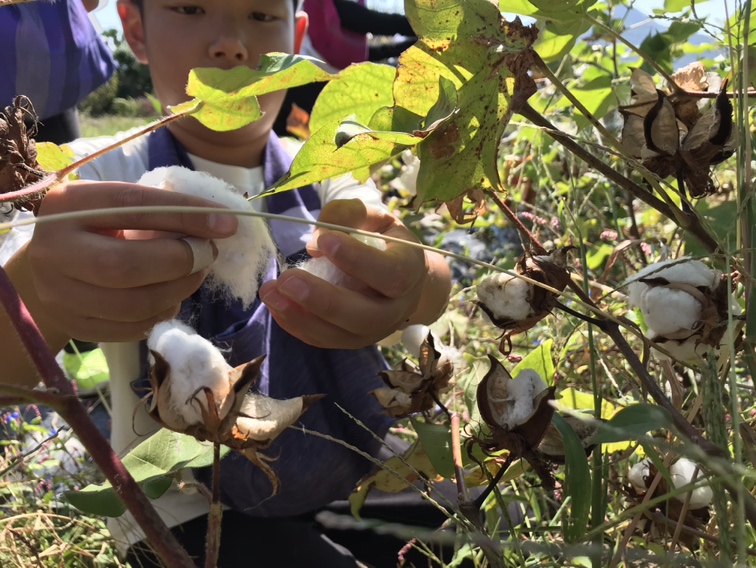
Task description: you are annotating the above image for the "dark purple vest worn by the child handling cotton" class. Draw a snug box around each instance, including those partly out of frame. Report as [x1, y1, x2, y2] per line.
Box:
[145, 128, 391, 517]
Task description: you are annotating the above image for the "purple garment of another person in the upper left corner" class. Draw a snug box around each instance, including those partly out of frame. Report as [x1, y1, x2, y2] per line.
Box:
[0, 0, 115, 119]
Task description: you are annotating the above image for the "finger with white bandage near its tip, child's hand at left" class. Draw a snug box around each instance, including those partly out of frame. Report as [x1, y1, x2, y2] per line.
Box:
[29, 231, 217, 289]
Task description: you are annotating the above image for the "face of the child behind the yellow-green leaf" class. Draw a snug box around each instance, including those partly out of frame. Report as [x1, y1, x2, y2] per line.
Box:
[119, 0, 306, 155]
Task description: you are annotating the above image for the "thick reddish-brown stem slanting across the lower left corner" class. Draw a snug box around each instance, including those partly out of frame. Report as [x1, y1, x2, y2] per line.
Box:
[0, 268, 194, 568]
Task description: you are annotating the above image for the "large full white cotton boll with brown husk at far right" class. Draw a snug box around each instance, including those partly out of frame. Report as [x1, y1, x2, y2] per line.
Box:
[627, 258, 741, 361]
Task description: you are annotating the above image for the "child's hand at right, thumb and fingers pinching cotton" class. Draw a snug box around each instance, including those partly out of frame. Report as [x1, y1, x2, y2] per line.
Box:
[260, 200, 450, 349]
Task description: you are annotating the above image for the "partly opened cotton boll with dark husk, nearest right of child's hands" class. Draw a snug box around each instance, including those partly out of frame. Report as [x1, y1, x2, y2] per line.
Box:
[476, 247, 571, 354]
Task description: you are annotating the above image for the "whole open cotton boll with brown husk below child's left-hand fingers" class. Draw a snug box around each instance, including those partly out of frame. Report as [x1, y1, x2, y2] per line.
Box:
[147, 320, 322, 493]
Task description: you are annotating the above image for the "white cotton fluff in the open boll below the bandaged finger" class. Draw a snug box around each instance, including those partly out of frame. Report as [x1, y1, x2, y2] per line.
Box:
[147, 320, 231, 425]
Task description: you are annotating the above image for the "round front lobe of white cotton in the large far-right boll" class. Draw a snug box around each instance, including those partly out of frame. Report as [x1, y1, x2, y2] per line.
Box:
[641, 287, 702, 337]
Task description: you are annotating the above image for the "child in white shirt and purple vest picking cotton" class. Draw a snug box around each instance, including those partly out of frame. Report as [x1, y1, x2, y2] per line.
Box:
[0, 0, 450, 566]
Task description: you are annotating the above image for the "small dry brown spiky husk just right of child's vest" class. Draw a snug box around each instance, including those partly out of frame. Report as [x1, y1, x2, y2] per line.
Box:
[371, 333, 454, 418]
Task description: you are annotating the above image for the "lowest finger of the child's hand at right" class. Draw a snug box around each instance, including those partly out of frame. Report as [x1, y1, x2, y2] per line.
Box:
[260, 269, 414, 339]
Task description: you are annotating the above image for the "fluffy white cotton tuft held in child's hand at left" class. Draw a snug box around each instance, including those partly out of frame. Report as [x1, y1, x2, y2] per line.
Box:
[137, 166, 276, 307]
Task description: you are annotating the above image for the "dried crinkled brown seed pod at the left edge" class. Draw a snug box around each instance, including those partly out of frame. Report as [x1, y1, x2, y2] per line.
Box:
[0, 96, 43, 211]
